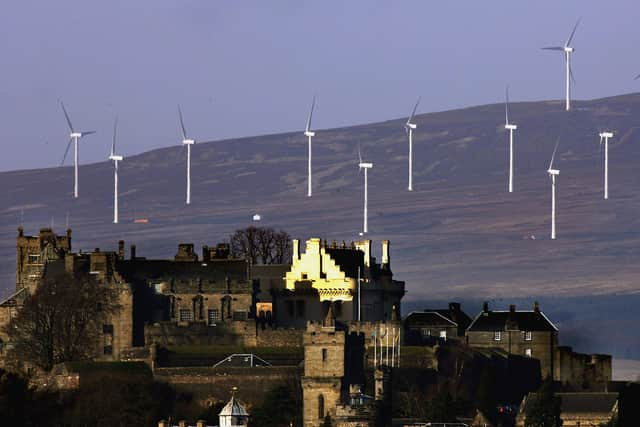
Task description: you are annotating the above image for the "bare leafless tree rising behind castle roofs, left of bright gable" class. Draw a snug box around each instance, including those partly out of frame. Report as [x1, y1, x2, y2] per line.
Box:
[229, 227, 291, 265]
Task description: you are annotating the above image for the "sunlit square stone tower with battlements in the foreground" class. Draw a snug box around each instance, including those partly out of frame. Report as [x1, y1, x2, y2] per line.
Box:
[302, 322, 345, 427]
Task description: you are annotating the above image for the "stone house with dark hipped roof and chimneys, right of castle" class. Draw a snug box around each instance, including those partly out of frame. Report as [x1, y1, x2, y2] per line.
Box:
[466, 303, 558, 378]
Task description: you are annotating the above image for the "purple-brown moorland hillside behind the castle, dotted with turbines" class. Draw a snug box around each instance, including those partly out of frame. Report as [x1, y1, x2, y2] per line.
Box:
[0, 94, 640, 299]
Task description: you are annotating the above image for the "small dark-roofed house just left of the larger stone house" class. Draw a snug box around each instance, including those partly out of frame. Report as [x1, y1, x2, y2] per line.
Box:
[403, 302, 471, 345]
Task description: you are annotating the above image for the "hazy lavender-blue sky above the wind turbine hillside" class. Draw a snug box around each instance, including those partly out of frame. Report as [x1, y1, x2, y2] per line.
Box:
[0, 0, 640, 170]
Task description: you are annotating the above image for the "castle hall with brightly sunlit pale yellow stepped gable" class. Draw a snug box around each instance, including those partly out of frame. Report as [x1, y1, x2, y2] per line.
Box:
[273, 238, 405, 328]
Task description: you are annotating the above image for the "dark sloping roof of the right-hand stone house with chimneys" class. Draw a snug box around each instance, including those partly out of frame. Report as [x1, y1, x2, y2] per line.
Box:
[467, 310, 558, 332]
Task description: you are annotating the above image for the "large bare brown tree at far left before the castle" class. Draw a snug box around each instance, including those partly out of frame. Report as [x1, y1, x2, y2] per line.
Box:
[4, 273, 118, 371]
